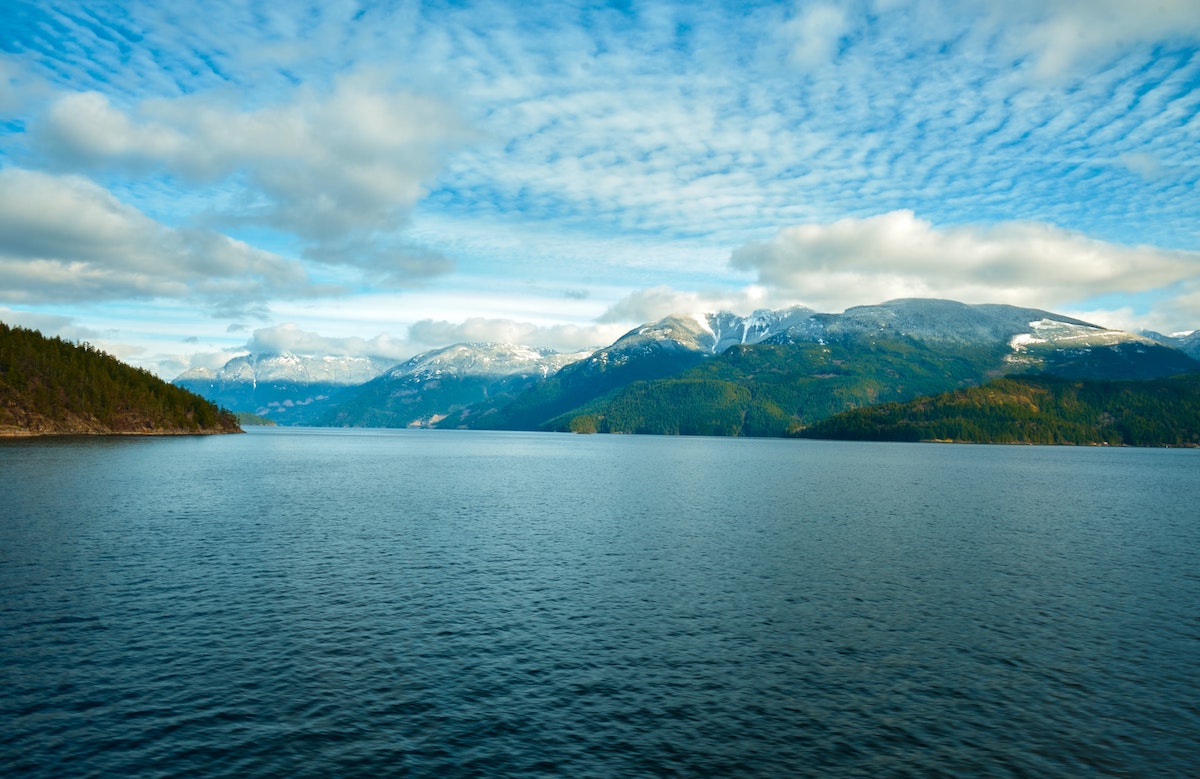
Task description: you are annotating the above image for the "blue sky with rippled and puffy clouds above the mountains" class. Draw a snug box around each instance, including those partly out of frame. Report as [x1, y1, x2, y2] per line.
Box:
[0, 0, 1200, 379]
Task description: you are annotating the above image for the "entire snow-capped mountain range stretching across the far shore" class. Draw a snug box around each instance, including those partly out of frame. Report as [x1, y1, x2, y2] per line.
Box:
[175, 299, 1200, 436]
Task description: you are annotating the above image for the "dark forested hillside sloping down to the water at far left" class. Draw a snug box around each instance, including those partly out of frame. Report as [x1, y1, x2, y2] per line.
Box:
[0, 323, 240, 433]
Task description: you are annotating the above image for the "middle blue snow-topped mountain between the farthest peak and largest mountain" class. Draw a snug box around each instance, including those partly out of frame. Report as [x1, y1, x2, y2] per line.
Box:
[311, 343, 588, 427]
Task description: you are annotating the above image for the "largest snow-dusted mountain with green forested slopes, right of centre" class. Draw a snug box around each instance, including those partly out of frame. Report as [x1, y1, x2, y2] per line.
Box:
[439, 299, 1200, 436]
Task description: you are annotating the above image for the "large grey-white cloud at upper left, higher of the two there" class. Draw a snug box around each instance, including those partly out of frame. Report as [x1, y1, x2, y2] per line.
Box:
[29, 72, 473, 277]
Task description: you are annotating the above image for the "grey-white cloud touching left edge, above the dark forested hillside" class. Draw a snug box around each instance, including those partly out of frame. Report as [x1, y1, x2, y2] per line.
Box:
[0, 168, 312, 312]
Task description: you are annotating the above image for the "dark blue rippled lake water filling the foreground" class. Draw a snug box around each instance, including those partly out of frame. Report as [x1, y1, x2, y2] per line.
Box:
[0, 429, 1200, 779]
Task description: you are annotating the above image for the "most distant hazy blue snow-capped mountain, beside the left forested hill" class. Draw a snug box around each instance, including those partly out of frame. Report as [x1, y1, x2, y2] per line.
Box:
[172, 353, 392, 424]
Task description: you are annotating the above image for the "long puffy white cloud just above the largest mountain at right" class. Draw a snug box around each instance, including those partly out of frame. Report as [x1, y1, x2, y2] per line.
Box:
[730, 210, 1200, 307]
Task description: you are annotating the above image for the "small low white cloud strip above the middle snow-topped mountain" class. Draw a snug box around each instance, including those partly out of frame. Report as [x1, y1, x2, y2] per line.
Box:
[408, 317, 625, 352]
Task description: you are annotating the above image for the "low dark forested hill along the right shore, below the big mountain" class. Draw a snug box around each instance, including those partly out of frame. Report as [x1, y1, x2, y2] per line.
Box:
[798, 374, 1200, 447]
